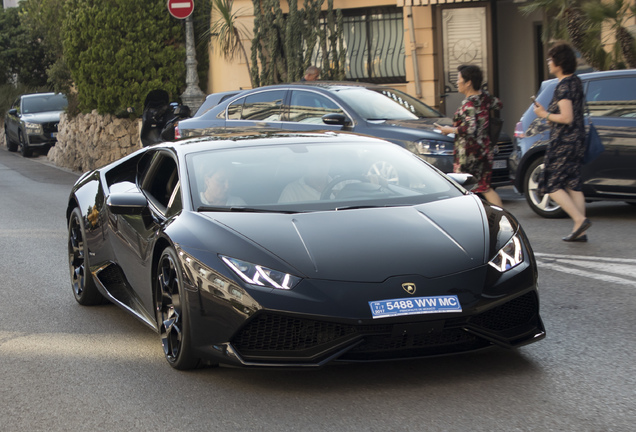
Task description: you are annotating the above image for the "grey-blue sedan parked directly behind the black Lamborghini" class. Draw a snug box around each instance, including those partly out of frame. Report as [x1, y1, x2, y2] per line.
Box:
[175, 81, 512, 187]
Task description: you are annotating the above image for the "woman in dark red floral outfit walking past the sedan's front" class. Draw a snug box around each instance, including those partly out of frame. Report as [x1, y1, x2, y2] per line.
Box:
[440, 65, 502, 207]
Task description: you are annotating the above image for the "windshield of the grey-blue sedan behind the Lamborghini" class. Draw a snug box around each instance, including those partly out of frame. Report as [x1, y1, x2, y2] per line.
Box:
[336, 87, 443, 120]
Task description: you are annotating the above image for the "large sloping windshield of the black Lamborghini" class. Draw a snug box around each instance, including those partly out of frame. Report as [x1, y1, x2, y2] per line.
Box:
[187, 141, 463, 213]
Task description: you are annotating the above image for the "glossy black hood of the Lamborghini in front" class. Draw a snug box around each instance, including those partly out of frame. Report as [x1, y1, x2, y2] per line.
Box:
[205, 195, 487, 282]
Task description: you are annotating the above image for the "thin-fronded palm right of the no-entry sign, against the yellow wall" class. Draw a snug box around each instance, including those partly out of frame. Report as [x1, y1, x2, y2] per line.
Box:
[204, 0, 254, 88]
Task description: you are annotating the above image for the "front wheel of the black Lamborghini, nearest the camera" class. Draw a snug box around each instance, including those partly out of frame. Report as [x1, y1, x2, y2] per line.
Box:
[155, 247, 200, 370]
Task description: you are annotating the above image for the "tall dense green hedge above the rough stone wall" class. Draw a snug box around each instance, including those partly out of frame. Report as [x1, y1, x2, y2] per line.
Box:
[62, 0, 185, 115]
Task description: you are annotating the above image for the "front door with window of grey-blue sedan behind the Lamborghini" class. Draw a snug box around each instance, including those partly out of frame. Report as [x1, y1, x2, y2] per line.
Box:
[283, 89, 346, 131]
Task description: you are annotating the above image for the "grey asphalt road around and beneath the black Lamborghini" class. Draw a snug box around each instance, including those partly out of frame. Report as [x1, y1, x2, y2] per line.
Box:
[0, 148, 636, 431]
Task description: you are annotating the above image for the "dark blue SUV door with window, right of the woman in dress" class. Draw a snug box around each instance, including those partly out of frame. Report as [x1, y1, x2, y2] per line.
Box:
[582, 75, 636, 196]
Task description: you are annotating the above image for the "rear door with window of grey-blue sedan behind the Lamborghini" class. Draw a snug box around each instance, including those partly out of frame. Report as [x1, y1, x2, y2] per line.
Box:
[225, 89, 287, 132]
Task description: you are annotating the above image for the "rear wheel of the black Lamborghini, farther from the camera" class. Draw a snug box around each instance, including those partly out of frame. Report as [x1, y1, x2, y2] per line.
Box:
[68, 208, 106, 306]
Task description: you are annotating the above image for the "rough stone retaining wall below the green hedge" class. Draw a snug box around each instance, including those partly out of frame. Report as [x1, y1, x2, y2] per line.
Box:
[47, 111, 142, 172]
